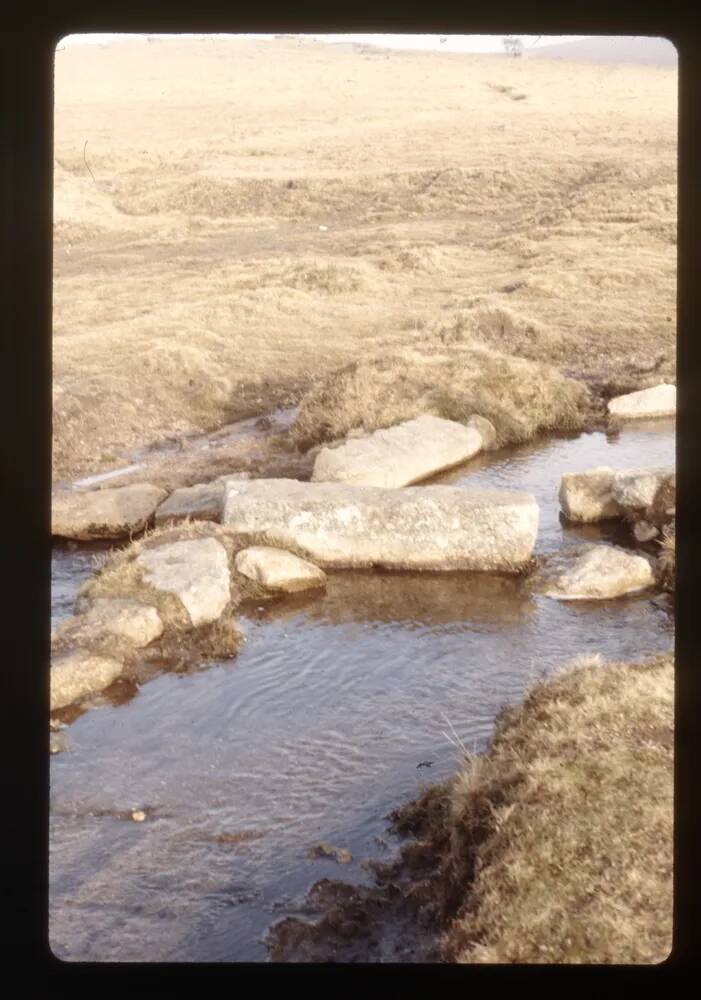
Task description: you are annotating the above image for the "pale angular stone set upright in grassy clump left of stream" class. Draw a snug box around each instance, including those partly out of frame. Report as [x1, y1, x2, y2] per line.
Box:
[136, 538, 231, 626]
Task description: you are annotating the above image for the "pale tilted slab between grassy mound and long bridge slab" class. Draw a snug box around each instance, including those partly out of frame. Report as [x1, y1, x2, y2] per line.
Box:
[312, 415, 483, 488]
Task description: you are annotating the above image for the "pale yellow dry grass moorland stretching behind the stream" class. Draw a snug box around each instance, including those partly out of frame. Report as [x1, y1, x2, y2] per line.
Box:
[53, 37, 677, 479]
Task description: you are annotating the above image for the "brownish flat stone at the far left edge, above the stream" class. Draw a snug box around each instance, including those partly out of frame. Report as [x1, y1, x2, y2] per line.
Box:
[51, 483, 167, 541]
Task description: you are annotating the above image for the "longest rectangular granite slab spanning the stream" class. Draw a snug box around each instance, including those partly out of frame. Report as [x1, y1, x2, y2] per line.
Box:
[223, 479, 538, 572]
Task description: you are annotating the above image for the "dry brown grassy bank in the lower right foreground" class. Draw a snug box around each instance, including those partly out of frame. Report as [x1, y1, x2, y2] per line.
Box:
[392, 654, 674, 964]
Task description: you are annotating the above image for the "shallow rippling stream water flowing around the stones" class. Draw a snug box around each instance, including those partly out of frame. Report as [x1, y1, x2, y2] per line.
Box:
[50, 422, 674, 961]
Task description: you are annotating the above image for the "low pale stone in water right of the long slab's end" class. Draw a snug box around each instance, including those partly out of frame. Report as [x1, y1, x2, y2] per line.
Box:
[547, 545, 655, 601]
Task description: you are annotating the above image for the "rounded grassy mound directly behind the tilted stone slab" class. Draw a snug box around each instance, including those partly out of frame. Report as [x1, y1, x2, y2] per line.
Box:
[292, 344, 590, 447]
